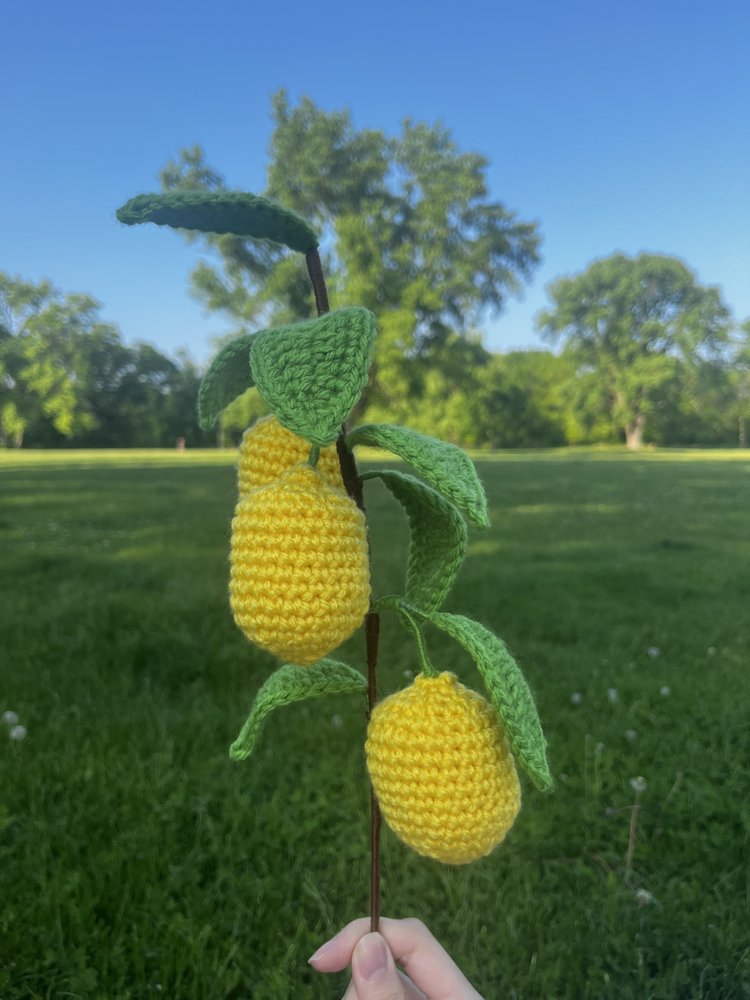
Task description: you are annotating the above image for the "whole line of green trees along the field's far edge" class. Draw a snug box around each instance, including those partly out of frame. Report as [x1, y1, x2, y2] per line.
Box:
[0, 91, 750, 448]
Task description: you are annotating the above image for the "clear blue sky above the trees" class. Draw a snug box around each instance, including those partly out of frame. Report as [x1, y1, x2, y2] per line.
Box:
[0, 0, 750, 361]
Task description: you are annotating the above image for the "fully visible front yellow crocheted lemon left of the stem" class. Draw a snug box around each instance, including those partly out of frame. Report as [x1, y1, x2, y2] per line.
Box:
[229, 464, 370, 666]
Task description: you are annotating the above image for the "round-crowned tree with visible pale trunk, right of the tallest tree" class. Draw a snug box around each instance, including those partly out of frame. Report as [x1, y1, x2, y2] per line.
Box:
[539, 253, 729, 450]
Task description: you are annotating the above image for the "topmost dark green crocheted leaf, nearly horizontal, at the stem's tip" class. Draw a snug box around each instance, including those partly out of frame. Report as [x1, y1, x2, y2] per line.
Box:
[117, 191, 318, 253]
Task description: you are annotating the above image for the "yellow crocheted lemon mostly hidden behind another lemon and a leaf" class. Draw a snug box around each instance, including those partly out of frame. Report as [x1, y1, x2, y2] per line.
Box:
[237, 415, 344, 493]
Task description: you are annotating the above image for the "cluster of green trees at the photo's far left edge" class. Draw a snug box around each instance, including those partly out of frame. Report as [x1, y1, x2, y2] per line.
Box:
[0, 273, 206, 447]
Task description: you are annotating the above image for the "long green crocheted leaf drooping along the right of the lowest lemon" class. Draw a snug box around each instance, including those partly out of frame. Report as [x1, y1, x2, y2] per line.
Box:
[406, 605, 552, 791]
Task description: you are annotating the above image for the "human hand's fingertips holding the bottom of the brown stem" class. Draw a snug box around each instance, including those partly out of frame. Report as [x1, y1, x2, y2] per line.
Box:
[310, 917, 482, 1000]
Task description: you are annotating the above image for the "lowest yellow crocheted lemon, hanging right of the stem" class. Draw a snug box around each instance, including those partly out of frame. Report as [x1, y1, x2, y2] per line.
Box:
[365, 673, 521, 864]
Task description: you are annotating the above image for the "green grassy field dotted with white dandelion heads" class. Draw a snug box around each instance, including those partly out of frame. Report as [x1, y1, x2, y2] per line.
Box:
[0, 452, 750, 1000]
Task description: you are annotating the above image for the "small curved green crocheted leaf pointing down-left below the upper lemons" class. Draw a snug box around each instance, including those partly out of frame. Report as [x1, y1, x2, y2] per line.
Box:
[229, 660, 367, 760]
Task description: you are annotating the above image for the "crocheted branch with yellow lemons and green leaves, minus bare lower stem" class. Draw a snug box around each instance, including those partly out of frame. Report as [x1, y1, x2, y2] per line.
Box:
[118, 186, 552, 876]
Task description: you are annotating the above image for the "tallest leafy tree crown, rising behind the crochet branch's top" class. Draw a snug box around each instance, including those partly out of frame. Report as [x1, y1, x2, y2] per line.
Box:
[161, 91, 539, 418]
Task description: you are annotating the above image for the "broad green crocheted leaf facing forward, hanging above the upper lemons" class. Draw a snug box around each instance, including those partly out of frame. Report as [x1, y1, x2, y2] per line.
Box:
[250, 306, 375, 447]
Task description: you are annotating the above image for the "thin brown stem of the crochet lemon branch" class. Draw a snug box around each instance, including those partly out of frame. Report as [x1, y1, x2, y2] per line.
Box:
[305, 240, 381, 931]
